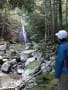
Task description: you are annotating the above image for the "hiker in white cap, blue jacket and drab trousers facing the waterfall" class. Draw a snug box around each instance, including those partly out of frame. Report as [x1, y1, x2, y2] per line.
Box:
[55, 30, 68, 90]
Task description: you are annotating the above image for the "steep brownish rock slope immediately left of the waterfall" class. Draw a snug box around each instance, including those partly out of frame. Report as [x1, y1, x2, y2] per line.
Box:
[0, 11, 20, 41]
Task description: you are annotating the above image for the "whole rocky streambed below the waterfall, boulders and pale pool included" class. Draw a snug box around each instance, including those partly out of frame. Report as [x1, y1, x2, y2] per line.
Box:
[0, 43, 55, 90]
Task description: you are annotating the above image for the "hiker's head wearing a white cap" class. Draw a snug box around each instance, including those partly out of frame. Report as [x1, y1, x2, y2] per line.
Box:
[55, 30, 68, 42]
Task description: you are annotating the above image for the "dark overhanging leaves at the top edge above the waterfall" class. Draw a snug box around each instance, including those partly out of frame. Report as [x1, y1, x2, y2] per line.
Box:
[8, 0, 34, 13]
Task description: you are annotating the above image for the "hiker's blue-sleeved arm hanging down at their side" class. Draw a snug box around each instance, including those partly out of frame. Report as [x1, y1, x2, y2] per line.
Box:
[55, 45, 65, 78]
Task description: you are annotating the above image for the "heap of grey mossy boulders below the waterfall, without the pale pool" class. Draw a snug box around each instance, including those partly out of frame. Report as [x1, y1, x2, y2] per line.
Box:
[0, 42, 55, 90]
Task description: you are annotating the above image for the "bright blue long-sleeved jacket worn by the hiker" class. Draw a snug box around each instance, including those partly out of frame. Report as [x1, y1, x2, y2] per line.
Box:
[55, 41, 68, 78]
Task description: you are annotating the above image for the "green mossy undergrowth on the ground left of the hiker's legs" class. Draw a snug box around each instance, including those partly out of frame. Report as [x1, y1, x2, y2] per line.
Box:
[30, 72, 57, 90]
